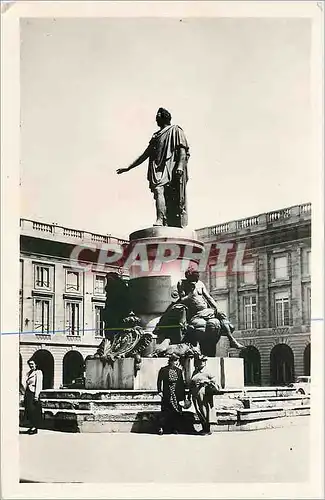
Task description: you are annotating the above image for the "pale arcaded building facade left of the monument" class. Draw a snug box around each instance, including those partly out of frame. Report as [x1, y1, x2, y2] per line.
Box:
[20, 219, 127, 389]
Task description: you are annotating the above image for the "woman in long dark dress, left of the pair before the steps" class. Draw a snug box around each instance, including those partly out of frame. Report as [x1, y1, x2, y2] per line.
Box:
[157, 354, 185, 434]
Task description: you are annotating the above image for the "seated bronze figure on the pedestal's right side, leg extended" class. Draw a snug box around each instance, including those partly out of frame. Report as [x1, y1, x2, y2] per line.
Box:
[153, 269, 243, 357]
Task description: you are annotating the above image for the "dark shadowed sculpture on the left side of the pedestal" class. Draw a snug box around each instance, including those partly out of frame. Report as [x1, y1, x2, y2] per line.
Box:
[95, 272, 152, 364]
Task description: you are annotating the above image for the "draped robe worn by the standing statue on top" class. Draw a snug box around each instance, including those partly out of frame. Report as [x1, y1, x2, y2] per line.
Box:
[148, 125, 190, 227]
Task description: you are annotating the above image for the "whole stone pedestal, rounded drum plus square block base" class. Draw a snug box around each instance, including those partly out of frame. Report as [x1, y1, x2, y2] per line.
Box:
[86, 227, 240, 390]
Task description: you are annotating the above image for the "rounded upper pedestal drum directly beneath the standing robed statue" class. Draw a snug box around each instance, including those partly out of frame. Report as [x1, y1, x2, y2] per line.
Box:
[128, 226, 204, 332]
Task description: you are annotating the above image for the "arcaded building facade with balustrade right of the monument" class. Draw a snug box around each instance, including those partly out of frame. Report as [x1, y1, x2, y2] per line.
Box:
[196, 203, 311, 385]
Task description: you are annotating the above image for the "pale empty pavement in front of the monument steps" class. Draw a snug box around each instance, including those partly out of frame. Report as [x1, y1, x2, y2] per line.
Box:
[20, 417, 309, 483]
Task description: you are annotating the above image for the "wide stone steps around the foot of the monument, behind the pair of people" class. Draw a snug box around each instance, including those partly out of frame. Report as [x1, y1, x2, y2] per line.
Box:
[20, 387, 310, 432]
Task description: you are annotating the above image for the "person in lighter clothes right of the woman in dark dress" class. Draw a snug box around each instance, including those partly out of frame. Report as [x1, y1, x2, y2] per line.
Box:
[190, 355, 218, 436]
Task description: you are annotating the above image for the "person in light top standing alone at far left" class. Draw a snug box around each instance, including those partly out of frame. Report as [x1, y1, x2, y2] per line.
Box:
[24, 359, 43, 434]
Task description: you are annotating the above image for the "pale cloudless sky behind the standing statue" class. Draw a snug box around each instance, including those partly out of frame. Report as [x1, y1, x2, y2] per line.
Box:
[20, 18, 315, 237]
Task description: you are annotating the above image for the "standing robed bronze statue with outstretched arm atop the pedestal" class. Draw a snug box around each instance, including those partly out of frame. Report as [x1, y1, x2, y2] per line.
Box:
[117, 108, 189, 227]
